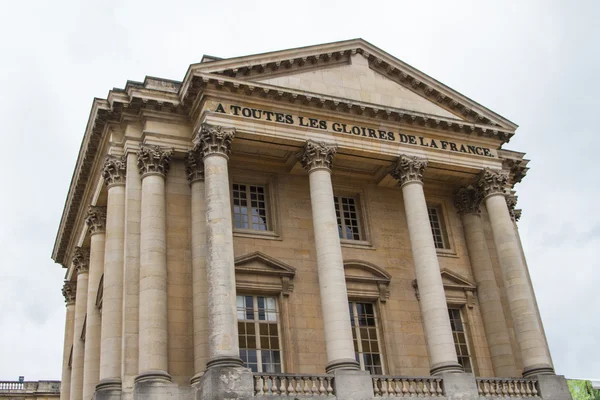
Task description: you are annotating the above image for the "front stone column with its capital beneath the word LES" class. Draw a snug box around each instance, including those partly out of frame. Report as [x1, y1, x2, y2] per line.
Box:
[299, 140, 359, 373]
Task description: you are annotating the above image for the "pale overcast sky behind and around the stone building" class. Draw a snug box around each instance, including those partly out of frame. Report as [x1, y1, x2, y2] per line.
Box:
[0, 0, 600, 380]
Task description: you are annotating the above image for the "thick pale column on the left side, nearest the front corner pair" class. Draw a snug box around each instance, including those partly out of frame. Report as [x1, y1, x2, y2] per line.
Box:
[136, 145, 172, 383]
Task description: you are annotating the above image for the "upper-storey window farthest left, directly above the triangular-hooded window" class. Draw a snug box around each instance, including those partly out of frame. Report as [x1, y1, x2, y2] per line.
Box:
[233, 183, 270, 231]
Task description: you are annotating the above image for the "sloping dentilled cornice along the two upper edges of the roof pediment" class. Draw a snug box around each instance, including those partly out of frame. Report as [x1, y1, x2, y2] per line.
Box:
[180, 39, 517, 131]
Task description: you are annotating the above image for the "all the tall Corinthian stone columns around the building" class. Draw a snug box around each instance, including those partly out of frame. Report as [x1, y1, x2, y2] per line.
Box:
[61, 124, 553, 400]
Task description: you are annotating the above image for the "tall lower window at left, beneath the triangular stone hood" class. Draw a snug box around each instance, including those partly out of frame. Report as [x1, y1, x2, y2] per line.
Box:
[236, 296, 281, 373]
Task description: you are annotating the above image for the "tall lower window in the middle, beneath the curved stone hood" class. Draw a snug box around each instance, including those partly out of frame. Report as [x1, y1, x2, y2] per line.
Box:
[348, 301, 383, 375]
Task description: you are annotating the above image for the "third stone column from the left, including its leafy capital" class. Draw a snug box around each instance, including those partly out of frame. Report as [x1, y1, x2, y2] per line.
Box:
[83, 206, 106, 400]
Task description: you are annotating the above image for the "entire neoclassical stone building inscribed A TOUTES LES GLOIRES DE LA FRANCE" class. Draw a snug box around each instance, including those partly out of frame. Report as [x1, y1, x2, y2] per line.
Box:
[53, 39, 569, 400]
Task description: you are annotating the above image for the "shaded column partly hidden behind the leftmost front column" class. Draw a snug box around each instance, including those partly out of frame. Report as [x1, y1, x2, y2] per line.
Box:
[186, 147, 208, 384]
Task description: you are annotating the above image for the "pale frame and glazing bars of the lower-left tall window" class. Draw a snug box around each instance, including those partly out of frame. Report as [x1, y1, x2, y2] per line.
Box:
[236, 293, 286, 373]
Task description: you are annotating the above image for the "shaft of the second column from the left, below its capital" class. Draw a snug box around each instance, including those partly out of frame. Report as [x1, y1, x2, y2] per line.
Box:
[70, 267, 88, 400]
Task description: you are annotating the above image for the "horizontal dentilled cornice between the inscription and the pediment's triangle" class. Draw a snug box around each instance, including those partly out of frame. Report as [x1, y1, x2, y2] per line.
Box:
[184, 74, 514, 143]
